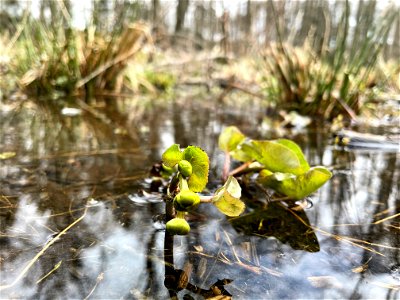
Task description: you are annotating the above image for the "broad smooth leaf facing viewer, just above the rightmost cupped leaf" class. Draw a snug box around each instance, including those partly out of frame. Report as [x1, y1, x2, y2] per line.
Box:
[242, 141, 304, 175]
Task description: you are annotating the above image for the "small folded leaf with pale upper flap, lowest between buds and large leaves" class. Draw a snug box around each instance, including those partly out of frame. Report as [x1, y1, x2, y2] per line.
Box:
[213, 176, 245, 217]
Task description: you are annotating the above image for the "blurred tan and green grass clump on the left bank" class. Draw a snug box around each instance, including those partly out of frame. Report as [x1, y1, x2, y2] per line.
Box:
[12, 17, 149, 99]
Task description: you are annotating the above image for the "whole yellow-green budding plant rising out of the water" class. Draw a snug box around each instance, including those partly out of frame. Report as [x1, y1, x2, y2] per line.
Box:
[160, 126, 332, 235]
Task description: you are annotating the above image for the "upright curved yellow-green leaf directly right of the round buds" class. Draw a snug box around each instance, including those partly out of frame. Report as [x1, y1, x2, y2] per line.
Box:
[182, 146, 209, 192]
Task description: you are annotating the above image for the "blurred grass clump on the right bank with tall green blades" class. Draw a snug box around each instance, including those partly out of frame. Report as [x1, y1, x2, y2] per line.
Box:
[263, 2, 398, 120]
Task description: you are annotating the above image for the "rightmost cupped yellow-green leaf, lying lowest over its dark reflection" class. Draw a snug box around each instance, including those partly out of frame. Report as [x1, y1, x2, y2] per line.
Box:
[258, 167, 332, 199]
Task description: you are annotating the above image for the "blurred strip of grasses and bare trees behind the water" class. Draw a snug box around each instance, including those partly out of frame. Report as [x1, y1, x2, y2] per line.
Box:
[0, 0, 400, 119]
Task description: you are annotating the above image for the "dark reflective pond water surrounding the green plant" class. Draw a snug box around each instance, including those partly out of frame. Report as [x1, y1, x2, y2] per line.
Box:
[0, 99, 400, 299]
